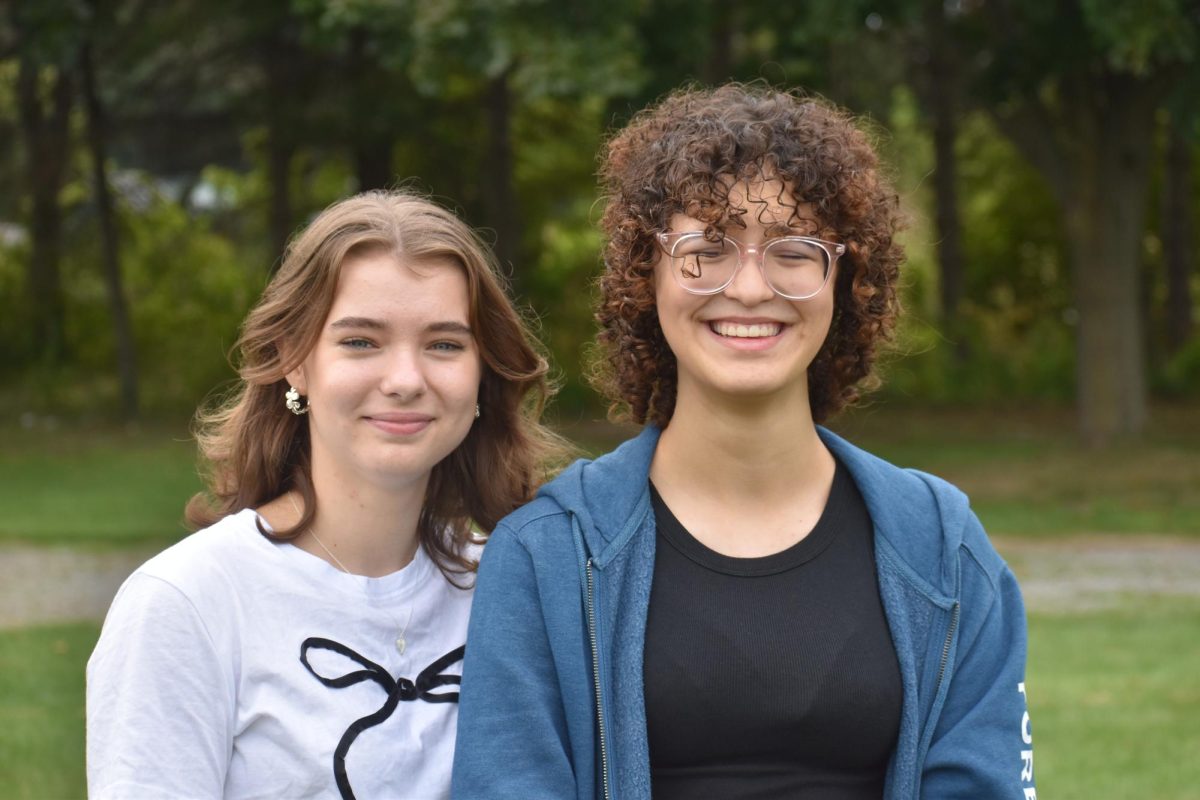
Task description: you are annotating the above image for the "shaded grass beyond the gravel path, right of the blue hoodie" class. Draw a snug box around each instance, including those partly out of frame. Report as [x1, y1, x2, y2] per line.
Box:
[833, 407, 1200, 537]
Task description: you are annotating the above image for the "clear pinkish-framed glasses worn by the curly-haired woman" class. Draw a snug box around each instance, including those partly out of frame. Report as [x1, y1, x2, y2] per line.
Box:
[656, 230, 846, 300]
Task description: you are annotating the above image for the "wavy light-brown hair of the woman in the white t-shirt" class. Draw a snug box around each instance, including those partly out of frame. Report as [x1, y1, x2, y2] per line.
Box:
[186, 191, 568, 581]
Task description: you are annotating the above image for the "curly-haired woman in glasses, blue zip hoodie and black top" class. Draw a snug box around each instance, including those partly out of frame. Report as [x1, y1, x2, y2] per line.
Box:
[452, 85, 1034, 800]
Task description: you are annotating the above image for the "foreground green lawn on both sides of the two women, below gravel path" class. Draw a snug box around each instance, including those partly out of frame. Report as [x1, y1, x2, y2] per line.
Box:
[0, 601, 1200, 800]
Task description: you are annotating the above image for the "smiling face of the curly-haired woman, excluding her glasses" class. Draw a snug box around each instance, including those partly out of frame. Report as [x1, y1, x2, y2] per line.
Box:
[654, 180, 836, 408]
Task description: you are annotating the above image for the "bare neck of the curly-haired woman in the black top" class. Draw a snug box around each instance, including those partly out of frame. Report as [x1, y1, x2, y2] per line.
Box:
[650, 384, 833, 506]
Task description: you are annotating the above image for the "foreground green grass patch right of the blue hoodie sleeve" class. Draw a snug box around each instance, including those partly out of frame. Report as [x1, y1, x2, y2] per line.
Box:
[1026, 600, 1200, 800]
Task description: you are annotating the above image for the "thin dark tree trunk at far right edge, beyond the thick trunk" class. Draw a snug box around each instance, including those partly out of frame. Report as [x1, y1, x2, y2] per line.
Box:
[1163, 116, 1195, 355]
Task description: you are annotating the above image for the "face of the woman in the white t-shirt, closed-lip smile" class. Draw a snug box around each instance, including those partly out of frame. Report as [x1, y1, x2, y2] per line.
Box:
[288, 251, 481, 488]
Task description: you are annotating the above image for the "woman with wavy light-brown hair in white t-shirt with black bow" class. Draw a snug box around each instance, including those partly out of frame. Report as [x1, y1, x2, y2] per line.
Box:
[88, 192, 566, 798]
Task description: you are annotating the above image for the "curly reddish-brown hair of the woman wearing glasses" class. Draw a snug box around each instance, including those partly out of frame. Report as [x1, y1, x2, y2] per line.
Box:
[593, 84, 904, 426]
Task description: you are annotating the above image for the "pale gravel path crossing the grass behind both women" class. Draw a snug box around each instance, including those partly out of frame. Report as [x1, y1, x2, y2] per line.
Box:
[0, 535, 1200, 630]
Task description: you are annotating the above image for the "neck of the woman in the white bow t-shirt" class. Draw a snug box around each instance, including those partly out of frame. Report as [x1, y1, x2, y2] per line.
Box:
[290, 458, 428, 577]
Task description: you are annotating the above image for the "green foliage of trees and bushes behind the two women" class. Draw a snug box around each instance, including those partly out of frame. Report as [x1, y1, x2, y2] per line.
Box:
[0, 0, 1200, 424]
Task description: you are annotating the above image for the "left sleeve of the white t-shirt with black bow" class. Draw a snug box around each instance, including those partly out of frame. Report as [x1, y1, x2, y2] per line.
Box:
[88, 573, 235, 800]
